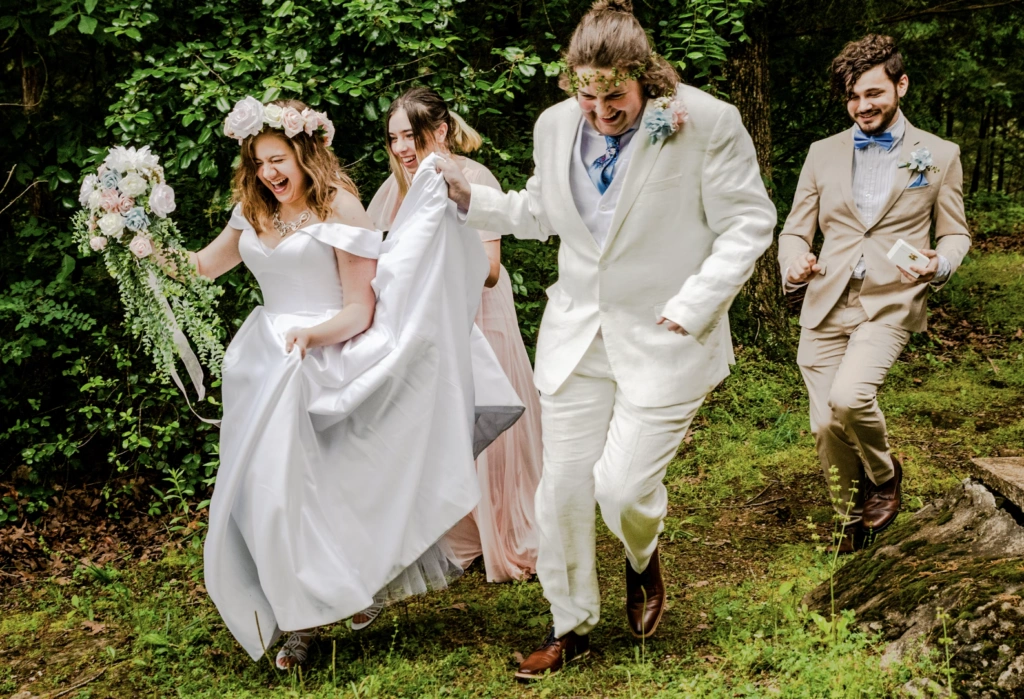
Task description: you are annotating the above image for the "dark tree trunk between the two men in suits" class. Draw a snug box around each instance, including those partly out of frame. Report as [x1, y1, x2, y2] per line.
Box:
[725, 25, 793, 352]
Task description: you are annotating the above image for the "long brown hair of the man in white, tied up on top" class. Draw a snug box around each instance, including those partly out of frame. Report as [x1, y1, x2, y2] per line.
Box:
[558, 0, 680, 99]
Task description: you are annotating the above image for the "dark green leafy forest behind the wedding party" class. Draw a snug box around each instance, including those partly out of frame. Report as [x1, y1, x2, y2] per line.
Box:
[0, 0, 1024, 526]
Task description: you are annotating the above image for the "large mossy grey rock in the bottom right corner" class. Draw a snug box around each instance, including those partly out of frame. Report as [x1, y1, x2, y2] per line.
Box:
[805, 479, 1024, 699]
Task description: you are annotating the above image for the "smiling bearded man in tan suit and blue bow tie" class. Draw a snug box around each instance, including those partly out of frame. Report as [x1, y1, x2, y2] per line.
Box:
[779, 35, 971, 553]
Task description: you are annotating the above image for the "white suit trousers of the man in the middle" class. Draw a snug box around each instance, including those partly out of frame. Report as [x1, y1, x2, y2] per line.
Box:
[537, 331, 703, 637]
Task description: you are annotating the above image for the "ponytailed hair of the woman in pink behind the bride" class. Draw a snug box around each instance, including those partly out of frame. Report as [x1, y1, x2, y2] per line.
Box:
[384, 87, 483, 198]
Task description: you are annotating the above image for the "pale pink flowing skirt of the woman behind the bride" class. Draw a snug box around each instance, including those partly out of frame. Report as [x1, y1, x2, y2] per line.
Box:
[445, 266, 542, 582]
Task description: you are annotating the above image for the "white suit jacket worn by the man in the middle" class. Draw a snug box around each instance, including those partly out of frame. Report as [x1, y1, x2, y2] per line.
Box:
[466, 85, 775, 407]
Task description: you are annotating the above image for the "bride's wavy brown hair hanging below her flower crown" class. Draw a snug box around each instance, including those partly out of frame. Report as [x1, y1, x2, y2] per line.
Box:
[233, 99, 359, 231]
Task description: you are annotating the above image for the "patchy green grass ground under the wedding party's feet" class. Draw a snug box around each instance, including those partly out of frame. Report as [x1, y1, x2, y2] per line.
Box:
[0, 252, 1024, 699]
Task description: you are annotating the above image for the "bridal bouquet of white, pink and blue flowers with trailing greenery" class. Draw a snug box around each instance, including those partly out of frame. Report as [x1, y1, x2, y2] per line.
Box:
[73, 146, 224, 390]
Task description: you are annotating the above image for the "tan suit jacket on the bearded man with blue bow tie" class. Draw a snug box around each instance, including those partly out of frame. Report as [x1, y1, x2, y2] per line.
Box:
[778, 122, 971, 333]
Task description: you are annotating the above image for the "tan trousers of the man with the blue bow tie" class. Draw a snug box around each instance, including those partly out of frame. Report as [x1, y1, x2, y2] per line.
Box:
[797, 279, 910, 522]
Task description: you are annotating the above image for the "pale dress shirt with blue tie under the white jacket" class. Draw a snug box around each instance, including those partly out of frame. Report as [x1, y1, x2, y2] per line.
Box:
[569, 118, 639, 250]
